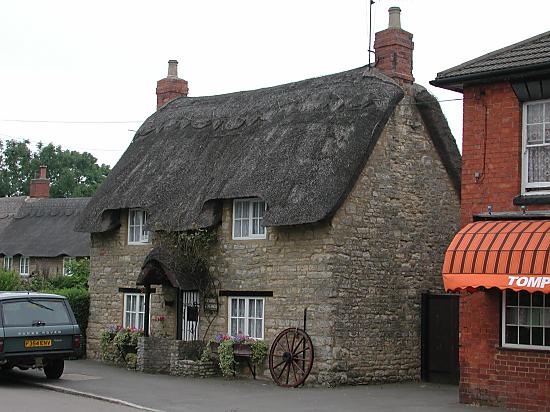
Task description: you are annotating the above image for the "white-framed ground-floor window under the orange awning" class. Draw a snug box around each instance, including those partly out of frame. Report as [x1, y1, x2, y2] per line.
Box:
[502, 290, 550, 350]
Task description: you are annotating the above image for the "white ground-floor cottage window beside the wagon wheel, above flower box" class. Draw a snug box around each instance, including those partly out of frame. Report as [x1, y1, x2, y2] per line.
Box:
[229, 297, 265, 339]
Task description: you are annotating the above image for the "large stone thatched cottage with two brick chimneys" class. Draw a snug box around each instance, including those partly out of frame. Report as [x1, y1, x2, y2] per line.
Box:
[78, 9, 460, 384]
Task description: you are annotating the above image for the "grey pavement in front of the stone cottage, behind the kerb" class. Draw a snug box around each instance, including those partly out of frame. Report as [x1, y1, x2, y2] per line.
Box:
[8, 360, 504, 412]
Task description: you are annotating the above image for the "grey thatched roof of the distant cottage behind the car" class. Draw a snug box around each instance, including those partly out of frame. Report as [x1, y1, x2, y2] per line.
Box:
[0, 197, 90, 257]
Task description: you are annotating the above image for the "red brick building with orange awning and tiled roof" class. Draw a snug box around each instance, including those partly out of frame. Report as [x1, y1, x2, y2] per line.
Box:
[432, 32, 550, 411]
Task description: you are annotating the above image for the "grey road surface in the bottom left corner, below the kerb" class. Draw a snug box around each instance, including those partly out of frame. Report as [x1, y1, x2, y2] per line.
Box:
[0, 373, 136, 412]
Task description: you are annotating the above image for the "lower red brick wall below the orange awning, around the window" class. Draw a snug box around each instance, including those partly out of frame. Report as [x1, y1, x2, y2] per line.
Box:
[459, 290, 550, 412]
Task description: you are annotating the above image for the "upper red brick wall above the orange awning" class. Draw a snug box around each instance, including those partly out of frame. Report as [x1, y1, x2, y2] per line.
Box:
[460, 83, 548, 226]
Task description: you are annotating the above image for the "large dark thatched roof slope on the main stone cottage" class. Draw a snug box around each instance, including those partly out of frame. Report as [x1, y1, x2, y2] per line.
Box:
[77, 67, 458, 232]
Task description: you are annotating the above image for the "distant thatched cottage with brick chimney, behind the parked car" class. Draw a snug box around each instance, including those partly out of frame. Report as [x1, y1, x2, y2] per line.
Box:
[0, 166, 90, 278]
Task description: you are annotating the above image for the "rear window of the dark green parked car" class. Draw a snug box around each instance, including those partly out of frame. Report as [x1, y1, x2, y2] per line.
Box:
[2, 298, 71, 326]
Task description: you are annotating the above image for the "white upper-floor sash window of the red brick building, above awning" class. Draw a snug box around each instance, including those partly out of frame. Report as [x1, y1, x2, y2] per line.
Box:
[522, 100, 550, 194]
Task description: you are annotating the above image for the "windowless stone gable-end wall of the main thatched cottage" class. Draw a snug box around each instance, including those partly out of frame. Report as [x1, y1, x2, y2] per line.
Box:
[330, 87, 459, 383]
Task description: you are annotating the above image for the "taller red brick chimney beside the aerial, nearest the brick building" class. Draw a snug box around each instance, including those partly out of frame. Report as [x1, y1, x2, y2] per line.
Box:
[374, 7, 414, 84]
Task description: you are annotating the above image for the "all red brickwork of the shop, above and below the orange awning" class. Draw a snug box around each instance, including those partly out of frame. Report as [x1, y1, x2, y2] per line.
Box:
[460, 83, 550, 411]
